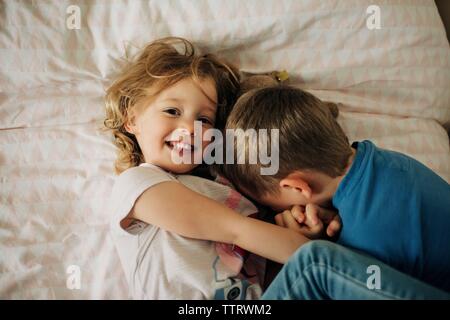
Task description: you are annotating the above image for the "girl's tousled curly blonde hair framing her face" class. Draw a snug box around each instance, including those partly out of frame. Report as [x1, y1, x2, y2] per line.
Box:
[104, 37, 240, 174]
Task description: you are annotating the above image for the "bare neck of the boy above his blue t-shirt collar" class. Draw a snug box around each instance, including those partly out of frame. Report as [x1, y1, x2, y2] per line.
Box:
[312, 147, 356, 207]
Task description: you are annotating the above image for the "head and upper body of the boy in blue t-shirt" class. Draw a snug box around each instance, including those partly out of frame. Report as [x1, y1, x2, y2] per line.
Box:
[221, 86, 450, 292]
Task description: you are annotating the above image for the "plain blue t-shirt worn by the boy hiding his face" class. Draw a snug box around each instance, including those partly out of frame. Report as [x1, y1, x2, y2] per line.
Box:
[333, 141, 450, 291]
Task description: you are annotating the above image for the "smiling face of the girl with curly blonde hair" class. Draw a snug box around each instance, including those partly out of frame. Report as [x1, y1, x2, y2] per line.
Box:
[126, 78, 217, 174]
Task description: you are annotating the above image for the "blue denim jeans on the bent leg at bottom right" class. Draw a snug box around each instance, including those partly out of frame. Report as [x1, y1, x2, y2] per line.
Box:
[262, 240, 450, 300]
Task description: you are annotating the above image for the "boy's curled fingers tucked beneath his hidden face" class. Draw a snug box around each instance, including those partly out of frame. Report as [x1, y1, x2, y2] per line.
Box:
[275, 204, 341, 239]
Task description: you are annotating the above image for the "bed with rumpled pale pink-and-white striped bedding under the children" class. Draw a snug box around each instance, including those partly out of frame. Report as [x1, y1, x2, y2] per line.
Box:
[0, 0, 450, 299]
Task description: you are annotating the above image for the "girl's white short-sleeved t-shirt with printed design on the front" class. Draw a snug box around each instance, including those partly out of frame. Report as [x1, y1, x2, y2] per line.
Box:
[110, 164, 265, 299]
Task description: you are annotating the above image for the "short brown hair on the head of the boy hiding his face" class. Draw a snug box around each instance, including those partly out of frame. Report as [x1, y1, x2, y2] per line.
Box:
[216, 85, 352, 198]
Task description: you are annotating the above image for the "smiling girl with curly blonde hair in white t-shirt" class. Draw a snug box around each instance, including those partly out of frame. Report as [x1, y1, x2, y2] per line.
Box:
[105, 38, 334, 299]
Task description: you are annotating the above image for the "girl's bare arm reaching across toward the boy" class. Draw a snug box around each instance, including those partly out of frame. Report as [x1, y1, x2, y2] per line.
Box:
[130, 181, 309, 263]
